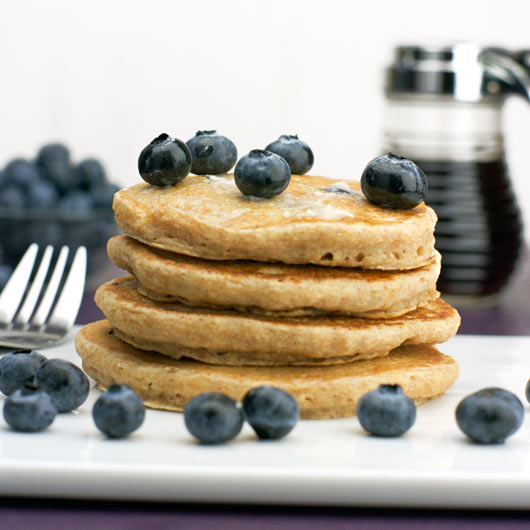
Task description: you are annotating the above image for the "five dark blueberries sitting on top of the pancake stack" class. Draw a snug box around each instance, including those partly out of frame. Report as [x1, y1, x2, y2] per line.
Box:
[138, 131, 427, 209]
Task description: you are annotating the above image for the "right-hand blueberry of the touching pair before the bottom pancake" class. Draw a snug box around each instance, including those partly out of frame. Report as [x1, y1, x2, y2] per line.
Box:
[243, 386, 299, 440]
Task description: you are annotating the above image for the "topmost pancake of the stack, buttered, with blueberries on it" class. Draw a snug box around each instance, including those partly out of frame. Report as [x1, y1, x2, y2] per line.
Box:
[113, 175, 436, 270]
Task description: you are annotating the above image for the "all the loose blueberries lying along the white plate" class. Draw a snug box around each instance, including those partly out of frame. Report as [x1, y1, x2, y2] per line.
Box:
[0, 350, 530, 444]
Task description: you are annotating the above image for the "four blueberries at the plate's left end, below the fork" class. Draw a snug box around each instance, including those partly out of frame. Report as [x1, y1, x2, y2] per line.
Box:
[0, 350, 145, 438]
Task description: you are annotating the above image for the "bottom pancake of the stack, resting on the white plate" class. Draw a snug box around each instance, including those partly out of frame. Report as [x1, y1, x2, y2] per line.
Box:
[76, 320, 458, 419]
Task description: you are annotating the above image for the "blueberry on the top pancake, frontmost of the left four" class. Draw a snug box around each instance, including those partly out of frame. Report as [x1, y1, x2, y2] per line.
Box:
[234, 149, 291, 199]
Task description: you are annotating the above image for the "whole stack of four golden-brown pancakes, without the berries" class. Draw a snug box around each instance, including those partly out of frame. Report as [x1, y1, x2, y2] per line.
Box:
[76, 175, 460, 418]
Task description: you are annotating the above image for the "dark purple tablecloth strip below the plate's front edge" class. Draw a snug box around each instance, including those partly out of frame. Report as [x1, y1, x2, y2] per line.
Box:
[0, 500, 530, 530]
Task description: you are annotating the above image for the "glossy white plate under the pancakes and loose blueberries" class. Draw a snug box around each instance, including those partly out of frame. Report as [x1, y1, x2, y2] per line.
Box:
[0, 333, 530, 509]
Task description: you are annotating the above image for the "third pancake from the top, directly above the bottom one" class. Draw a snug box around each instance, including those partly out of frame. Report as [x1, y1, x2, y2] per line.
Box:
[96, 276, 460, 365]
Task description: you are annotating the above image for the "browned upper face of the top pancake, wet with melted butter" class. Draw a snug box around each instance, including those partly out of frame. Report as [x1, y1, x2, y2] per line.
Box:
[128, 175, 432, 229]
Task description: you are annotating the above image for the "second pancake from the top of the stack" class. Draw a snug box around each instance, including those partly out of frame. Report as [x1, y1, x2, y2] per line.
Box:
[107, 236, 440, 318]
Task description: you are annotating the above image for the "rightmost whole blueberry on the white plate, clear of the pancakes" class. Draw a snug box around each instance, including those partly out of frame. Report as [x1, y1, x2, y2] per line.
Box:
[456, 388, 524, 444]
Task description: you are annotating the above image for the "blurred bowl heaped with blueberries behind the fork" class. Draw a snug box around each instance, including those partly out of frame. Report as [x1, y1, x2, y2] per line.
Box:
[0, 143, 120, 290]
